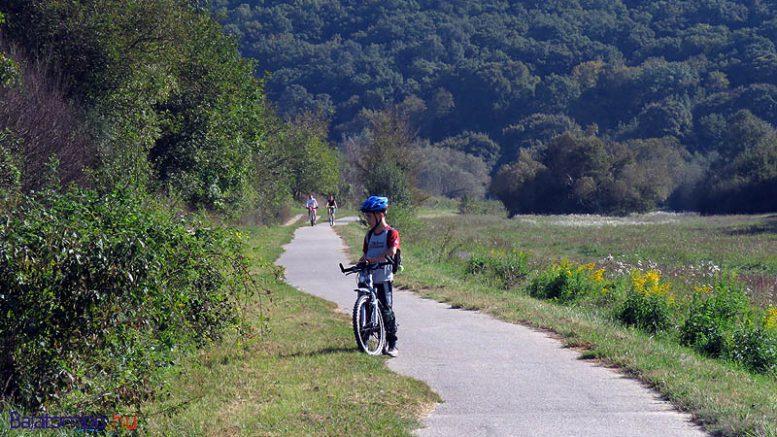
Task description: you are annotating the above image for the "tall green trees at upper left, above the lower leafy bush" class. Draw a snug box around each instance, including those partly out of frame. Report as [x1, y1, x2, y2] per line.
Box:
[0, 0, 337, 213]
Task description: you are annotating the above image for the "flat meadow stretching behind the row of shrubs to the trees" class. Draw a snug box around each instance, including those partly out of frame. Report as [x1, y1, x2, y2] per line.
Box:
[416, 213, 777, 306]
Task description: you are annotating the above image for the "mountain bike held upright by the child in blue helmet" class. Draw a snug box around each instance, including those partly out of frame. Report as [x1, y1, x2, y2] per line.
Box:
[340, 261, 394, 355]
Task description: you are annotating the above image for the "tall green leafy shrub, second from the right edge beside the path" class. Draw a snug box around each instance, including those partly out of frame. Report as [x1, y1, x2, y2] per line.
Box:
[680, 277, 749, 357]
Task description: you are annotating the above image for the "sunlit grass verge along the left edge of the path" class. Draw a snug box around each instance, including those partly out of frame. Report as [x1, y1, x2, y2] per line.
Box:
[0, 226, 440, 435]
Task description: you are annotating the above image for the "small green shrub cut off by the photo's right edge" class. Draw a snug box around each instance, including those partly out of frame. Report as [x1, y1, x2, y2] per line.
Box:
[729, 323, 777, 373]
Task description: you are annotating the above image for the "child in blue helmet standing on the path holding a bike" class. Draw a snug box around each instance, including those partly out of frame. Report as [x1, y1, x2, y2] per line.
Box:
[360, 196, 399, 357]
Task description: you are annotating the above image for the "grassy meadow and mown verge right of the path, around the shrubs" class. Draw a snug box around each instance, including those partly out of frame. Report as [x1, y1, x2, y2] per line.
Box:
[339, 214, 777, 435]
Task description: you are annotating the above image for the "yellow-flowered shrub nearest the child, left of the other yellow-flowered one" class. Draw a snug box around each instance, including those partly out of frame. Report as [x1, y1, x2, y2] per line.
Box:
[529, 260, 612, 302]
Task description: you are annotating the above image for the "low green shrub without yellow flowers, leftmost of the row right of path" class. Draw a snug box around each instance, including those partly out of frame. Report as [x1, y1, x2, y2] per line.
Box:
[467, 249, 529, 290]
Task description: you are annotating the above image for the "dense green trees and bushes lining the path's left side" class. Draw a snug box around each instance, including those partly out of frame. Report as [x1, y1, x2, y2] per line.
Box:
[0, 0, 340, 411]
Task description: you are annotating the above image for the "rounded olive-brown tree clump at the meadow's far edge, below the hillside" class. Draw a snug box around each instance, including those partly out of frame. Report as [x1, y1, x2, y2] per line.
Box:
[491, 133, 684, 214]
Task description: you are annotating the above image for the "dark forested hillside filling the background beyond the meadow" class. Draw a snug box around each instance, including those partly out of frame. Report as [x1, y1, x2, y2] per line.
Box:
[213, 0, 777, 212]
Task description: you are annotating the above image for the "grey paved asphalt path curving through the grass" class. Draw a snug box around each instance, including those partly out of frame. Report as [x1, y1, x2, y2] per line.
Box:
[278, 223, 704, 436]
